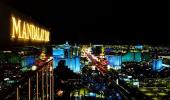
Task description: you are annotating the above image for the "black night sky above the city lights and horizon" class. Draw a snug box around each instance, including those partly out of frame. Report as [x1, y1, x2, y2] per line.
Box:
[1, 0, 170, 44]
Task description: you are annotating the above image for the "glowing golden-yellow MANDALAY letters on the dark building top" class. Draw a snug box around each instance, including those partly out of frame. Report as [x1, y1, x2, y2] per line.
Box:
[11, 16, 50, 42]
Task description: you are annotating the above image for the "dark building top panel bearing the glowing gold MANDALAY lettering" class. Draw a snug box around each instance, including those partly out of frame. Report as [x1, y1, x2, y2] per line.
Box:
[0, 3, 50, 47]
